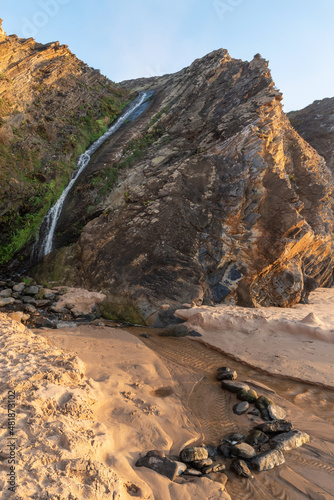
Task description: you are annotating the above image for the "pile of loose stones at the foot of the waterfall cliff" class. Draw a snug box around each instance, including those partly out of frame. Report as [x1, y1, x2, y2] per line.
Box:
[0, 277, 101, 328]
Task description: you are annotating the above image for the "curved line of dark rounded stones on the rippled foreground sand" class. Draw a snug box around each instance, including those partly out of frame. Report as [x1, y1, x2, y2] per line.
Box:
[136, 367, 310, 484]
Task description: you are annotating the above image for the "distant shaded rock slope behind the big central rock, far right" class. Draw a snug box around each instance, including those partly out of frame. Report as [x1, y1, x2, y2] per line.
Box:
[288, 97, 334, 172]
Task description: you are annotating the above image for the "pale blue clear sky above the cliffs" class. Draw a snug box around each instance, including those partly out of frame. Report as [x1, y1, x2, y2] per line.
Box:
[0, 0, 334, 111]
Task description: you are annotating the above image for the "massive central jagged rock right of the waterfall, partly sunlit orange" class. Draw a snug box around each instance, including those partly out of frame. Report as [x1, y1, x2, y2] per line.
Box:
[32, 50, 333, 323]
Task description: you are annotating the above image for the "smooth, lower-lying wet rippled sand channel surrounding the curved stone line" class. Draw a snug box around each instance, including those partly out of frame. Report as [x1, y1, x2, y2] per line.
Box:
[39, 320, 334, 500]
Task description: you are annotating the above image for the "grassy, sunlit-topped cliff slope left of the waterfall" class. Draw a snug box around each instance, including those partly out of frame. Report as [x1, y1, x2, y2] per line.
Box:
[0, 20, 129, 263]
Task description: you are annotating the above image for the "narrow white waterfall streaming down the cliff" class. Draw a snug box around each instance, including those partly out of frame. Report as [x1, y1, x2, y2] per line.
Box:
[32, 91, 153, 260]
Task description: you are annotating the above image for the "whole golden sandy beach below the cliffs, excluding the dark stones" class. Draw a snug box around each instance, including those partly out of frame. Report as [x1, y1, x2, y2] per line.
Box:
[0, 290, 334, 500]
